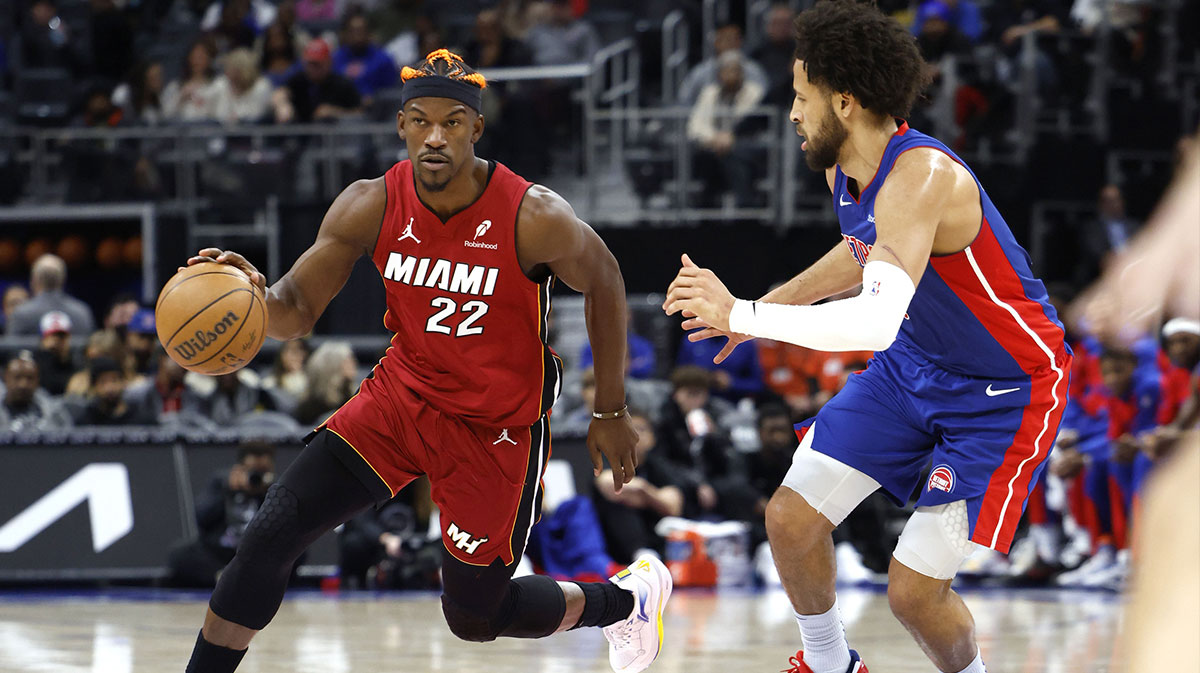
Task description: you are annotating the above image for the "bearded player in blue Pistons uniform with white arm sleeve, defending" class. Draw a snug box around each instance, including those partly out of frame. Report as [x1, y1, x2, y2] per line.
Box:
[664, 0, 1072, 673]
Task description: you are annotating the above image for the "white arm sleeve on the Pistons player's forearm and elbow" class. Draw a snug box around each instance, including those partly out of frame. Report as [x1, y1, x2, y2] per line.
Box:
[730, 260, 917, 350]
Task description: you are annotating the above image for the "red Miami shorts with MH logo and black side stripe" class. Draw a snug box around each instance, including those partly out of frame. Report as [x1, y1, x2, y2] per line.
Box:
[324, 379, 550, 566]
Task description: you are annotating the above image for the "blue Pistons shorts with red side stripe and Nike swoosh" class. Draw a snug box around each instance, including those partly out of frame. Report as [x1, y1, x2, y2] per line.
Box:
[797, 343, 1072, 553]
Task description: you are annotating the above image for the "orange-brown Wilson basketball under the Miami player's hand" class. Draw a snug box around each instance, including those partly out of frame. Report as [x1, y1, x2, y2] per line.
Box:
[155, 262, 266, 375]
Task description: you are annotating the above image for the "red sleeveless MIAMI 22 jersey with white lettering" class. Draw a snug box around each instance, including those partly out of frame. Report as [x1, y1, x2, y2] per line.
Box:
[359, 161, 563, 427]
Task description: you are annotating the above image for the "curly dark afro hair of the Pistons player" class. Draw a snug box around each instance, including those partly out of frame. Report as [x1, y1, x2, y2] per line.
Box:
[796, 0, 929, 118]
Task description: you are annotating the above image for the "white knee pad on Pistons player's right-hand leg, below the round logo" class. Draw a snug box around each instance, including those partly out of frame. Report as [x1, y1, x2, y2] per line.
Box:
[892, 500, 979, 579]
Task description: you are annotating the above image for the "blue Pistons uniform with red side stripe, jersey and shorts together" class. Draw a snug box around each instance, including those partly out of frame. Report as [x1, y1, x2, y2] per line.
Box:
[798, 120, 1072, 552]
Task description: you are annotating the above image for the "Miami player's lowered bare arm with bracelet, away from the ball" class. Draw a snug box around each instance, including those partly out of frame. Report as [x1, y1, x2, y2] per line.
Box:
[517, 185, 637, 491]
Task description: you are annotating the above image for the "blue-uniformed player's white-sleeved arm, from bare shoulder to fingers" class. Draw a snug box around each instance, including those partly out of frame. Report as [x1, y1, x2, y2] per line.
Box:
[666, 150, 958, 351]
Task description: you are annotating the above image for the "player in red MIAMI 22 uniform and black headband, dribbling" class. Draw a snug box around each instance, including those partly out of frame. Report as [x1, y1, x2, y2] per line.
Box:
[187, 49, 671, 673]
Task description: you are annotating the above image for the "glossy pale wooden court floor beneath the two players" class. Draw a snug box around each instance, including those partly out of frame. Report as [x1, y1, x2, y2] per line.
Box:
[0, 589, 1122, 673]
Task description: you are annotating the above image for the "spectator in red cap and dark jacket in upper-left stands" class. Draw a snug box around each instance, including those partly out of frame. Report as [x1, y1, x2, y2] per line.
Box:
[271, 38, 362, 124]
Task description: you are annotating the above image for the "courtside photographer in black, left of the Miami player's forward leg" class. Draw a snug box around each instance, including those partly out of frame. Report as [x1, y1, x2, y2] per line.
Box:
[167, 444, 275, 587]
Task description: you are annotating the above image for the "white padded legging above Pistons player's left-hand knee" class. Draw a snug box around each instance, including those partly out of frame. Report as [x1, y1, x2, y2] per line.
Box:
[784, 427, 880, 527]
